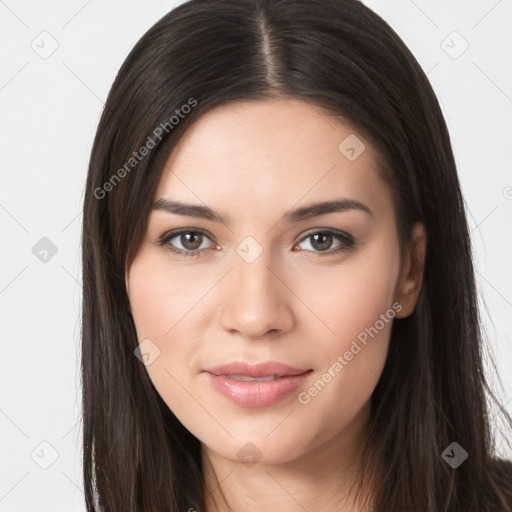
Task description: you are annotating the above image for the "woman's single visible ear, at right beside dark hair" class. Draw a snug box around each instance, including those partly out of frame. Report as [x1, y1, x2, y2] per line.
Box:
[395, 222, 427, 318]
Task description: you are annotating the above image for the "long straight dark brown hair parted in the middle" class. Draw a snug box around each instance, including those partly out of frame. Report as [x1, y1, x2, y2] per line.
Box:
[81, 0, 512, 512]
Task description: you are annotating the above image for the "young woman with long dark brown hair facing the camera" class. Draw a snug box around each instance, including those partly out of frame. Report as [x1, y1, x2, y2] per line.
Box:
[82, 0, 512, 512]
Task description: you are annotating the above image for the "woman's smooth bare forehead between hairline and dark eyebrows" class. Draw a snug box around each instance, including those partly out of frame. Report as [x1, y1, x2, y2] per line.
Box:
[156, 100, 390, 221]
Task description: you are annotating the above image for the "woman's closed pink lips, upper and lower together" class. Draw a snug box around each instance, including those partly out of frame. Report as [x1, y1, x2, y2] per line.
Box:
[205, 361, 313, 407]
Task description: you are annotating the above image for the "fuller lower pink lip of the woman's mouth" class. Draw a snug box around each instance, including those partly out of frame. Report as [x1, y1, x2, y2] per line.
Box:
[206, 370, 313, 407]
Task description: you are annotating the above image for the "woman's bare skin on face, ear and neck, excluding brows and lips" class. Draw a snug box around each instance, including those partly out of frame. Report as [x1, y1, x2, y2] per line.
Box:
[126, 100, 426, 512]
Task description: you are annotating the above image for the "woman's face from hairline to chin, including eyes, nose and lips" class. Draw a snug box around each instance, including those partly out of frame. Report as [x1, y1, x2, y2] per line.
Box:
[126, 100, 421, 463]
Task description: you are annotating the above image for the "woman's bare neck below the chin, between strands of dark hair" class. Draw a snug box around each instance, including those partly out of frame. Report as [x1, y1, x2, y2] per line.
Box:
[201, 404, 369, 512]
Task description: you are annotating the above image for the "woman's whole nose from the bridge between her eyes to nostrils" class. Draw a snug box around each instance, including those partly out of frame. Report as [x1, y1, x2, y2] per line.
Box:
[222, 237, 293, 337]
